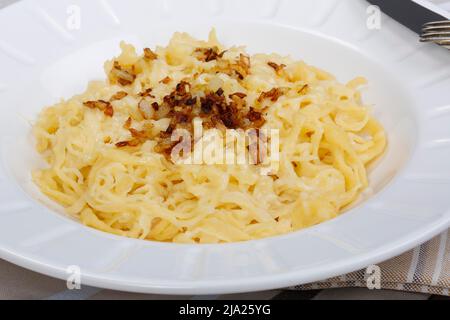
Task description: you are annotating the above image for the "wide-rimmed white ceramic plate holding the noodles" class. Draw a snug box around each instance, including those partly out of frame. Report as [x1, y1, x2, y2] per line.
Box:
[0, 0, 450, 294]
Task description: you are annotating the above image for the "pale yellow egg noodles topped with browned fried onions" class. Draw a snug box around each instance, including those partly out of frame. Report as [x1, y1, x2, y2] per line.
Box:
[32, 31, 386, 243]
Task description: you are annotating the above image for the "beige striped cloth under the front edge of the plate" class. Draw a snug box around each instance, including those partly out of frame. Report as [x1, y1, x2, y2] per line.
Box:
[0, 230, 450, 300]
